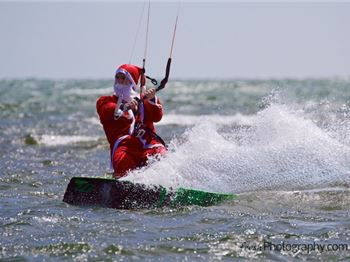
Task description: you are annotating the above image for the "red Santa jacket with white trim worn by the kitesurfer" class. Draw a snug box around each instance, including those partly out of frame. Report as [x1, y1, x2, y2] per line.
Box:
[96, 95, 163, 154]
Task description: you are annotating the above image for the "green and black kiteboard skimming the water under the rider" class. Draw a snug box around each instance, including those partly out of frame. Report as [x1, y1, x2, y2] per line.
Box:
[63, 177, 236, 209]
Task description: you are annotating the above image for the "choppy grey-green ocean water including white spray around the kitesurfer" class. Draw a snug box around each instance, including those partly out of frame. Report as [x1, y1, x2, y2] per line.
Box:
[0, 78, 350, 261]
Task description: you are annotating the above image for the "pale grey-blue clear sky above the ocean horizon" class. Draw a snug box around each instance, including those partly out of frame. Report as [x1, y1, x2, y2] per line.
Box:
[0, 1, 350, 79]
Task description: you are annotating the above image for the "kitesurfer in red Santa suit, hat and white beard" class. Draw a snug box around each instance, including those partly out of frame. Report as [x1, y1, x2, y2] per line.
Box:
[96, 64, 166, 178]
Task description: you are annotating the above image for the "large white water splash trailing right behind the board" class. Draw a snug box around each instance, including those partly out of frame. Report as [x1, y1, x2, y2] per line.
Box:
[127, 104, 350, 193]
